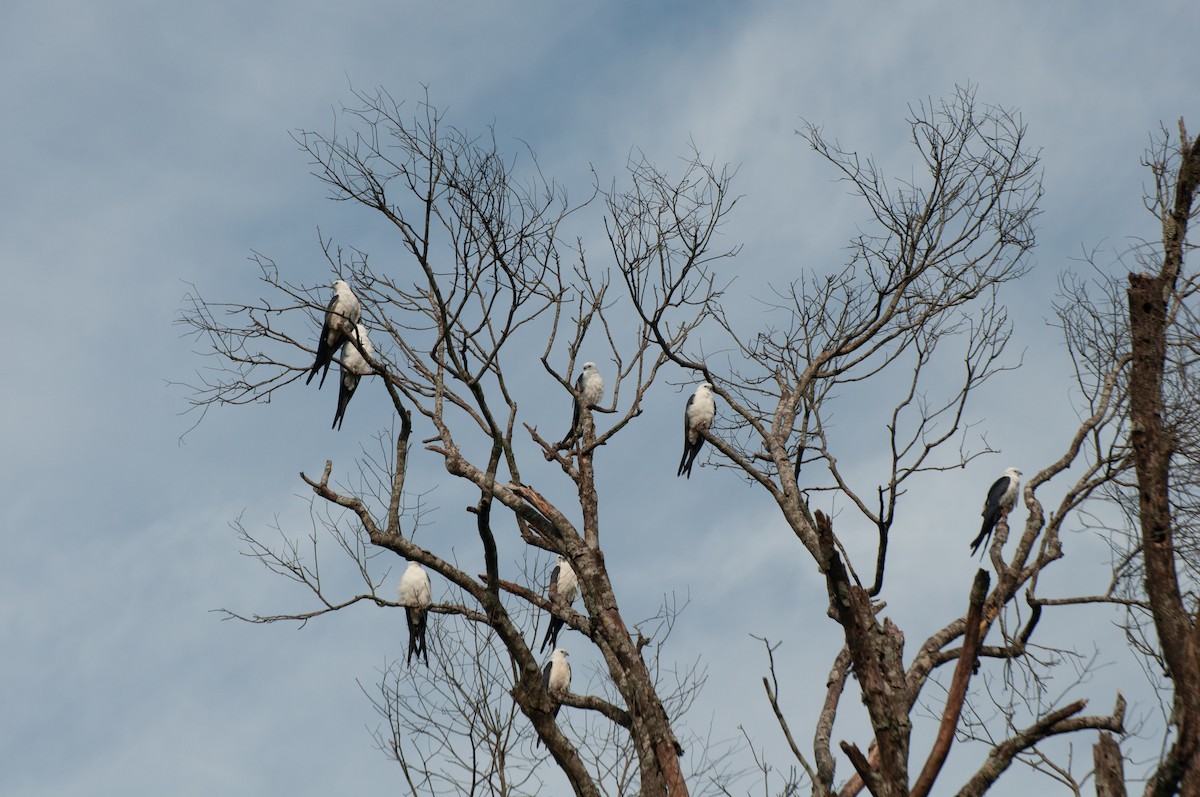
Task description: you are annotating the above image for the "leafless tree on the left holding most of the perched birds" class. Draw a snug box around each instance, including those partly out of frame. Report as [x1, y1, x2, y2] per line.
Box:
[182, 92, 733, 796]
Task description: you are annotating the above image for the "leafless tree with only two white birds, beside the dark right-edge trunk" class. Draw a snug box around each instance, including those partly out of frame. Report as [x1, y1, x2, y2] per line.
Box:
[624, 84, 1128, 797]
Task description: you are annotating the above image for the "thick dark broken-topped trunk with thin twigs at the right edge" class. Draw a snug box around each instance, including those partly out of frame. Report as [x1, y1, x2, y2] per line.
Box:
[1080, 120, 1200, 797]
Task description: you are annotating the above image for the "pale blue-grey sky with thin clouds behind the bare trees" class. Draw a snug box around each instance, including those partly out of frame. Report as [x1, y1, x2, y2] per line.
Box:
[0, 0, 1200, 795]
